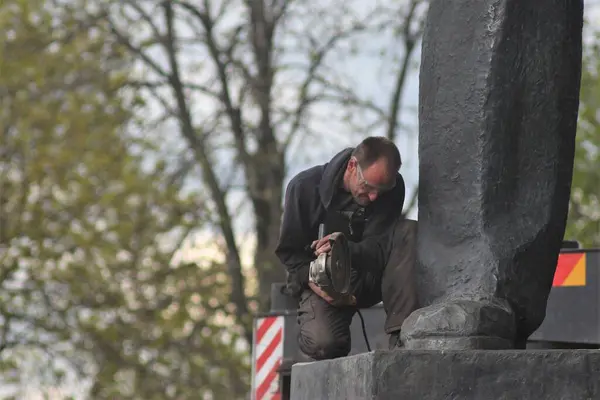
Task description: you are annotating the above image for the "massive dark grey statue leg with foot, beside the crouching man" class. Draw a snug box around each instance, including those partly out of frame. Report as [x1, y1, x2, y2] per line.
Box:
[402, 0, 583, 349]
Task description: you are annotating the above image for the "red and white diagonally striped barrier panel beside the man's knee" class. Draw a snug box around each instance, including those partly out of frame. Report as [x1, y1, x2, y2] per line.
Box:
[252, 316, 284, 400]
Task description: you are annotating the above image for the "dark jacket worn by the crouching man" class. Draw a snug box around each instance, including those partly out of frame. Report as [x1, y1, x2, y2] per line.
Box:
[275, 148, 405, 295]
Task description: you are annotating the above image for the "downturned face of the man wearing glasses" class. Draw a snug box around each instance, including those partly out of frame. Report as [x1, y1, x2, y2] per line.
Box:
[348, 157, 396, 206]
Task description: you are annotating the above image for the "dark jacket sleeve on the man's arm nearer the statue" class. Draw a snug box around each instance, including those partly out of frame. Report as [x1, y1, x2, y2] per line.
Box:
[349, 181, 405, 271]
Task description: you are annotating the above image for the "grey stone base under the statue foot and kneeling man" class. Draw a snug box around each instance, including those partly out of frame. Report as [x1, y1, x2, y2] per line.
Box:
[291, 350, 600, 400]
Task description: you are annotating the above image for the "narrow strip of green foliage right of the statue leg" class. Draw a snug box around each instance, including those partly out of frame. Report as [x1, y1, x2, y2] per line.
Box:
[565, 35, 600, 248]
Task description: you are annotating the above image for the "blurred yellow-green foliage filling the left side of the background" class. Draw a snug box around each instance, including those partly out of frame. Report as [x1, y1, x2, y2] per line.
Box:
[0, 0, 248, 400]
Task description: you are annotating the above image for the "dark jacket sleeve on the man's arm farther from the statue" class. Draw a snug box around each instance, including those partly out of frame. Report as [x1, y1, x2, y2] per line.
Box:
[275, 179, 316, 292]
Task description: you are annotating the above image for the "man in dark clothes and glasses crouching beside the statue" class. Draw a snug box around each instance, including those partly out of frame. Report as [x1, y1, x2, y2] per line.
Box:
[276, 137, 416, 360]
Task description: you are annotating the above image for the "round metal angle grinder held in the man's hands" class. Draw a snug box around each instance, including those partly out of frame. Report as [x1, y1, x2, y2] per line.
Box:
[309, 224, 353, 300]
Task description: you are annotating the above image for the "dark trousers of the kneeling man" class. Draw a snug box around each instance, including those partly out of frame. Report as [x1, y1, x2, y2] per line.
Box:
[298, 220, 417, 360]
